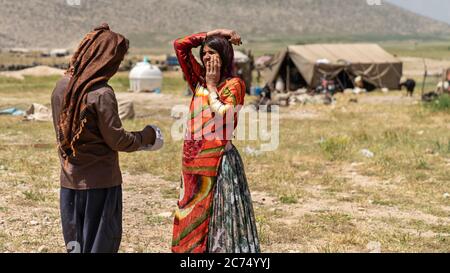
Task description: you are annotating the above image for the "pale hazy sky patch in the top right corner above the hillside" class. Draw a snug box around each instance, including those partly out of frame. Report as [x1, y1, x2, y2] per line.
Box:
[382, 0, 450, 24]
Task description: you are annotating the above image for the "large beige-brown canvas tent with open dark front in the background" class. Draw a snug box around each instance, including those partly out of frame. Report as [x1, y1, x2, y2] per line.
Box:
[263, 44, 403, 91]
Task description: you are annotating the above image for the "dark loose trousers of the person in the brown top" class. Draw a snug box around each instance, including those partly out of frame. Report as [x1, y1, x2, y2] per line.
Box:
[60, 186, 122, 253]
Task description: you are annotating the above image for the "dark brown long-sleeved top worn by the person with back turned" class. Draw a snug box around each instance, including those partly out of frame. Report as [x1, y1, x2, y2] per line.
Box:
[51, 76, 151, 190]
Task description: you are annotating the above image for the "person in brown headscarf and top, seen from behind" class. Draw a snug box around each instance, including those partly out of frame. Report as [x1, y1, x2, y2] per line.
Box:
[52, 24, 163, 252]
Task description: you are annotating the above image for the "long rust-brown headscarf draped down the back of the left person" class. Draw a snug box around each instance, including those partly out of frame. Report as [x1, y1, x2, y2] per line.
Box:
[58, 24, 129, 159]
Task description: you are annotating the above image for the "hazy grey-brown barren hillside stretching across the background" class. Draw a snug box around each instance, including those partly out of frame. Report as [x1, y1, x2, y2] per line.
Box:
[0, 0, 450, 48]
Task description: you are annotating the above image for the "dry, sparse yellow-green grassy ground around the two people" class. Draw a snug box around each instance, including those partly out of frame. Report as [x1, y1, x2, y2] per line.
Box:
[0, 71, 450, 252]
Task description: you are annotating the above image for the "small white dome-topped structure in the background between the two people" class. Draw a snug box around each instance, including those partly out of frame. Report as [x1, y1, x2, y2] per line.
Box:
[129, 57, 162, 93]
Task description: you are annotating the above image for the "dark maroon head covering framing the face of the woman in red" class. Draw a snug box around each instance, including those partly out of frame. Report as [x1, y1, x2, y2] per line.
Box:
[200, 35, 234, 79]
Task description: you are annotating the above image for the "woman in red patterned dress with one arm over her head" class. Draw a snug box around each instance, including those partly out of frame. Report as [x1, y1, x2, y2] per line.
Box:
[172, 29, 260, 253]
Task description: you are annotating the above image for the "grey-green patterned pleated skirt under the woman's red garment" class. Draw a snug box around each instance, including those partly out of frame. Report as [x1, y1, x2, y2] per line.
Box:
[207, 146, 260, 253]
